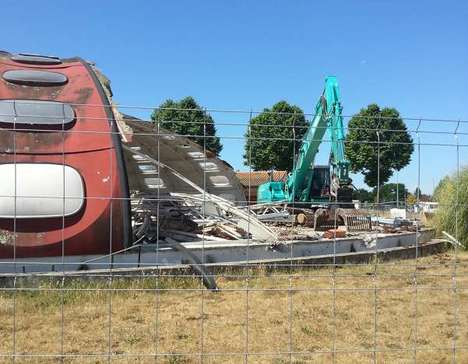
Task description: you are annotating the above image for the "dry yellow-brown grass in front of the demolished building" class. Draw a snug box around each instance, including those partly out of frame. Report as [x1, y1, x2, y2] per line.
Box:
[0, 253, 468, 363]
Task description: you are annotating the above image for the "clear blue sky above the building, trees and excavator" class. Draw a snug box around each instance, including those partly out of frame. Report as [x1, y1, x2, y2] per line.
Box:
[0, 0, 468, 192]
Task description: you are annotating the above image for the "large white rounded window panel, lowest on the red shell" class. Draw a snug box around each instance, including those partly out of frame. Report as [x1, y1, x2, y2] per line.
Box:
[0, 163, 84, 219]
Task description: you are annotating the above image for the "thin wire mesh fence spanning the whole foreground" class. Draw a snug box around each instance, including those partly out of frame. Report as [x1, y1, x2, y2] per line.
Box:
[0, 103, 468, 363]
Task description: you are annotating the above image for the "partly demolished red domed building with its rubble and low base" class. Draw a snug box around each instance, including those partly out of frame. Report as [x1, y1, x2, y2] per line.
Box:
[0, 52, 444, 272]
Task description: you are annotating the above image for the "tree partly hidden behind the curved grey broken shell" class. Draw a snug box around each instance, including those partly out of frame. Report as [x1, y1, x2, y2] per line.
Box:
[151, 96, 223, 155]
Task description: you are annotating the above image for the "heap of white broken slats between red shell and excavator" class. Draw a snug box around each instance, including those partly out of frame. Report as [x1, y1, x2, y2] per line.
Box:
[133, 193, 277, 243]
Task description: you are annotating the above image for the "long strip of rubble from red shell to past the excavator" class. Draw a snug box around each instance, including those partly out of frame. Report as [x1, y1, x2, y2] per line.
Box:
[130, 191, 422, 244]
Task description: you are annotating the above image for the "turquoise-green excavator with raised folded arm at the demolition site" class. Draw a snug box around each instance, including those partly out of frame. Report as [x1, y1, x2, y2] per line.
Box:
[257, 76, 353, 213]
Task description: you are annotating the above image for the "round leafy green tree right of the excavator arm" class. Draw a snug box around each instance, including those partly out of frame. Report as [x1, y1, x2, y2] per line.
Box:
[345, 104, 414, 187]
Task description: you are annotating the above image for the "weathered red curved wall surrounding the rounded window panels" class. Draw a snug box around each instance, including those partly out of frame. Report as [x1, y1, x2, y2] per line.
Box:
[0, 56, 128, 258]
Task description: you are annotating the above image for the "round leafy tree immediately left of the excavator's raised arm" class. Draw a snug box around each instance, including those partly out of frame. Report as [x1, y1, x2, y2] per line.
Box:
[244, 101, 308, 171]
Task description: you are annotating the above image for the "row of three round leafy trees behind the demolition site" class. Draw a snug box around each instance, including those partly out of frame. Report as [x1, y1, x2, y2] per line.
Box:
[151, 96, 414, 201]
